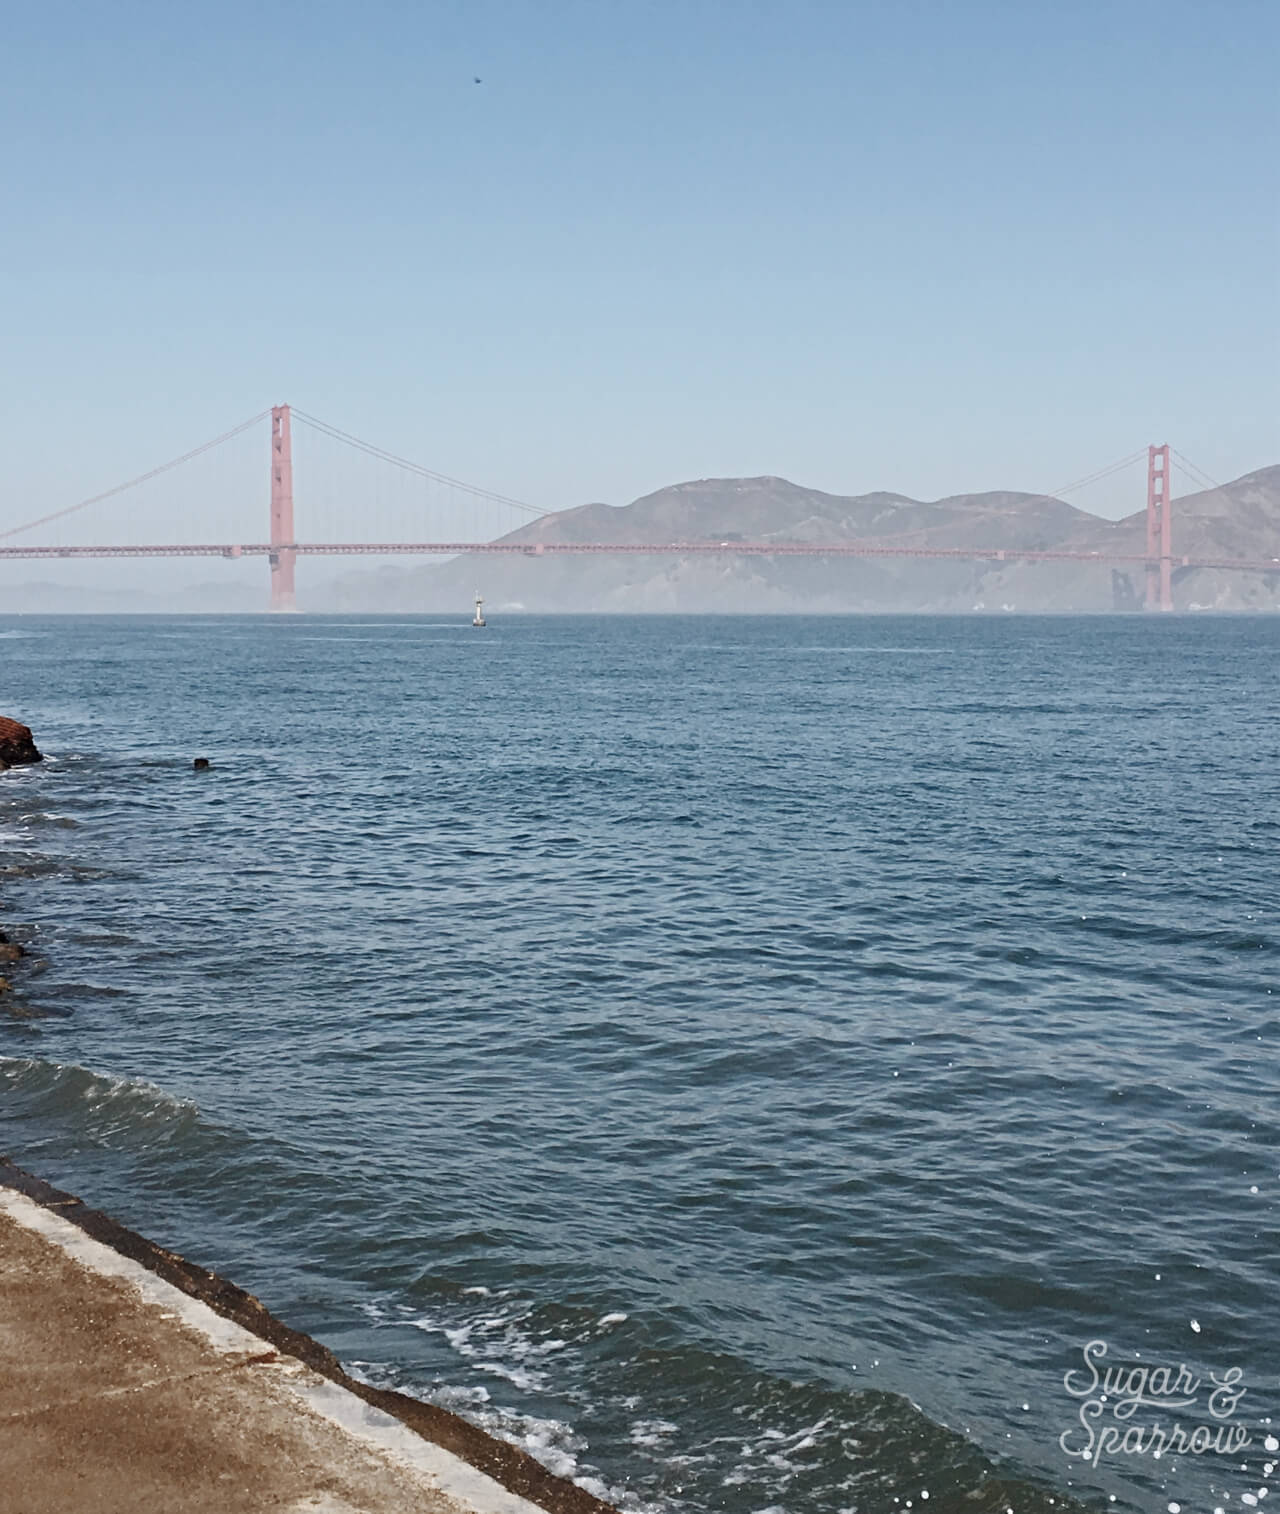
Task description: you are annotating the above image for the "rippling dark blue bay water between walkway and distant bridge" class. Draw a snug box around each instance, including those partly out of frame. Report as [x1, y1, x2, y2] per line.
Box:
[0, 616, 1280, 1514]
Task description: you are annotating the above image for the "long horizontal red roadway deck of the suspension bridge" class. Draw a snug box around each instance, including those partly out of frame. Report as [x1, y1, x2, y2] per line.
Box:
[0, 542, 1280, 574]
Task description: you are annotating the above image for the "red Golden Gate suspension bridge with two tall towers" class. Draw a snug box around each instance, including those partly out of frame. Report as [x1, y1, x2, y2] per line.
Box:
[0, 404, 1260, 612]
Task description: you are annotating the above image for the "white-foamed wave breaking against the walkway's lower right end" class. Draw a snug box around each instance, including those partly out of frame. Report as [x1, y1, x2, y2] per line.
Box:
[349, 1279, 1080, 1514]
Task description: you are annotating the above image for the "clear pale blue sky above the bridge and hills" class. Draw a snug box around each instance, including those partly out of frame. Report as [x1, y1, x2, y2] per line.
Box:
[0, 0, 1280, 542]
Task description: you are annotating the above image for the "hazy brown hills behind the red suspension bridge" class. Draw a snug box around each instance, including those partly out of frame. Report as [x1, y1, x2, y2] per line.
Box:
[308, 466, 1280, 613]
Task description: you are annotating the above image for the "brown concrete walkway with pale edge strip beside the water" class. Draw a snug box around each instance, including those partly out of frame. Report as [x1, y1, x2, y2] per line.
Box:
[0, 1166, 618, 1514]
